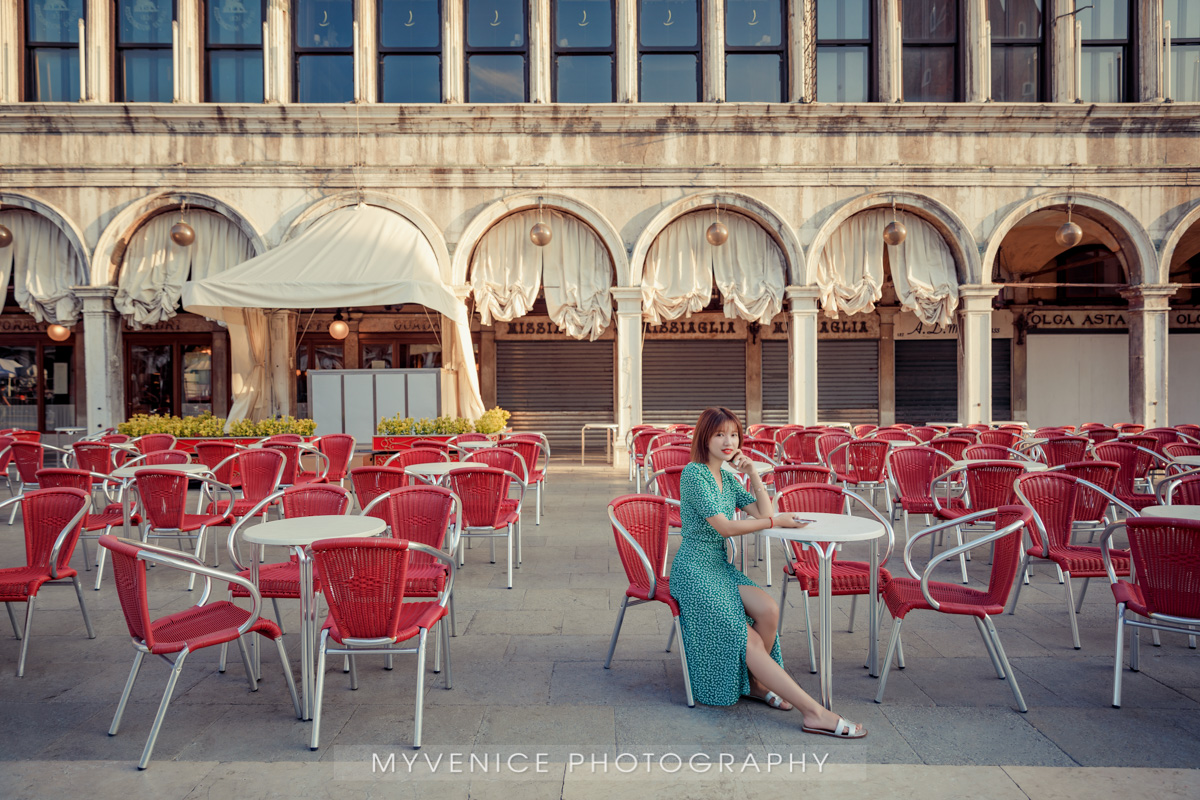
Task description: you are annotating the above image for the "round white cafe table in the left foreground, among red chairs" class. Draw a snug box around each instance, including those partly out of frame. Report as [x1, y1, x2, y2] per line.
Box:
[241, 515, 388, 720]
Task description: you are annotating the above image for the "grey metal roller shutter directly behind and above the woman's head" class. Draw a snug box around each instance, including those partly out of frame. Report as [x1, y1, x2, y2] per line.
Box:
[642, 341, 746, 425]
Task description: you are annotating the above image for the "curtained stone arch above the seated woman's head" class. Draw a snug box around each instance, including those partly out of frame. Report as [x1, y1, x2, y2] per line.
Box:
[629, 191, 809, 287]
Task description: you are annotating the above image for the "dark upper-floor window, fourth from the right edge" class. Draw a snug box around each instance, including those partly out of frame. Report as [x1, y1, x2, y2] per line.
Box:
[900, 0, 959, 103]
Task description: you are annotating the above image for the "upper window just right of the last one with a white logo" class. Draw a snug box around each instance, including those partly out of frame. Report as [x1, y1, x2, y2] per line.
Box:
[816, 0, 875, 103]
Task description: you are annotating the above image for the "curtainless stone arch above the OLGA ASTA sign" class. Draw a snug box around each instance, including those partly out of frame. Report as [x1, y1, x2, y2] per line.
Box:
[983, 191, 1156, 285]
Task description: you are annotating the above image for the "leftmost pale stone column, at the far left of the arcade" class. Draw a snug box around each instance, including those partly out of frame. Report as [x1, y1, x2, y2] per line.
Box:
[72, 287, 125, 433]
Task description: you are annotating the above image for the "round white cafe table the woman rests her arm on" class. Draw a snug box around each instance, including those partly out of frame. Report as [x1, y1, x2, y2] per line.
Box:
[762, 512, 887, 709]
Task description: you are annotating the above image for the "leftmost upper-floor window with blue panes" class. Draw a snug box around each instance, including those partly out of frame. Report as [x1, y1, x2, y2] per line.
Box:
[25, 0, 84, 103]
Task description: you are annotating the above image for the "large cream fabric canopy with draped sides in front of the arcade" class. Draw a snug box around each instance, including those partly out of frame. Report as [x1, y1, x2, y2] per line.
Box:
[182, 204, 485, 419]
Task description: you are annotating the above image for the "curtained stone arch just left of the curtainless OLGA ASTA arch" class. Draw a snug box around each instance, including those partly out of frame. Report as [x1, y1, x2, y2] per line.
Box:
[808, 190, 990, 285]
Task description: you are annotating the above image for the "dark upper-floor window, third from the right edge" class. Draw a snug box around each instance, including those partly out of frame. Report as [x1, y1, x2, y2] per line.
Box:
[988, 0, 1045, 103]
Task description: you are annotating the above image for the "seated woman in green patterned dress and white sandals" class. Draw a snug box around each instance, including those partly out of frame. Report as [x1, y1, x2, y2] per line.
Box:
[670, 408, 866, 739]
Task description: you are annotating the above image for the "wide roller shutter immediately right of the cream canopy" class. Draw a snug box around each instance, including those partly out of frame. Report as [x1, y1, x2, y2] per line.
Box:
[496, 341, 613, 455]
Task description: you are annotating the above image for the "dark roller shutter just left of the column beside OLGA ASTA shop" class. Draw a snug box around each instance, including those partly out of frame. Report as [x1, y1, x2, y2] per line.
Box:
[895, 339, 959, 425]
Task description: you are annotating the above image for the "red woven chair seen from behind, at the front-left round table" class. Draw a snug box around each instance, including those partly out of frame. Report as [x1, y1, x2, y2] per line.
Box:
[308, 539, 454, 750]
